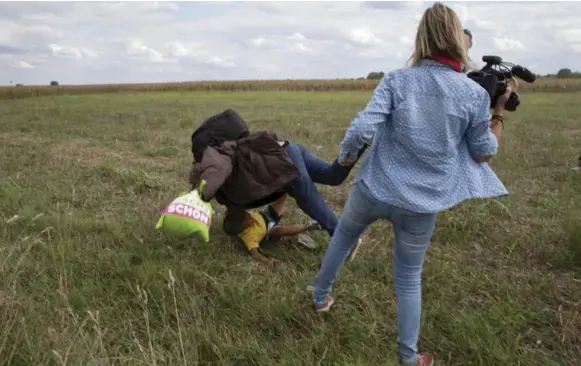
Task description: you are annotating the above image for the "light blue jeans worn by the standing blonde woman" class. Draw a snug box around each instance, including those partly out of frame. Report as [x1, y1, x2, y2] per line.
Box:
[313, 180, 436, 363]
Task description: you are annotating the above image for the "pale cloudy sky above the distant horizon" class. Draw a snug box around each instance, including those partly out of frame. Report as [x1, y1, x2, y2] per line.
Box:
[0, 1, 581, 85]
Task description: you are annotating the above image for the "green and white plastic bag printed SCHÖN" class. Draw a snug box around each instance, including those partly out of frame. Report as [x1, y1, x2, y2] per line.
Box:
[155, 182, 213, 243]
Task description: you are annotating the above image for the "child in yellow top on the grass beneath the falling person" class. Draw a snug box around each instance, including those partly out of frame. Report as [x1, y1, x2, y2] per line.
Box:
[223, 194, 322, 265]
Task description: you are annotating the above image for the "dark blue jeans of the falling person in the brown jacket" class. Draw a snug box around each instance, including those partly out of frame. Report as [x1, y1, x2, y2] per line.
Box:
[284, 142, 367, 236]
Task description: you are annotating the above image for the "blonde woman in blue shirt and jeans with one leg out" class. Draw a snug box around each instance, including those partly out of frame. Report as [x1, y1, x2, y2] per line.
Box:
[313, 3, 518, 366]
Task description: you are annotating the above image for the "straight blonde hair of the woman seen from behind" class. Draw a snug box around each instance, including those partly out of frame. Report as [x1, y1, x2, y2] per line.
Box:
[408, 3, 468, 66]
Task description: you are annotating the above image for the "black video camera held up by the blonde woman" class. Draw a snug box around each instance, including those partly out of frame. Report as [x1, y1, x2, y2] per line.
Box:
[467, 56, 536, 112]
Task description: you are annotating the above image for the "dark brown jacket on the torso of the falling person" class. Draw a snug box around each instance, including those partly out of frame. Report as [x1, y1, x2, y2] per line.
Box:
[192, 131, 299, 208]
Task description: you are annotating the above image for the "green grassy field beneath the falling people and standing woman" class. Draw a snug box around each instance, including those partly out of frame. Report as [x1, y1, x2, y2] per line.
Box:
[0, 92, 581, 366]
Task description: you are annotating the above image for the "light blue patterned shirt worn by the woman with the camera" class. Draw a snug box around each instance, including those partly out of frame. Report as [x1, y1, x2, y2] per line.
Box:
[339, 60, 508, 213]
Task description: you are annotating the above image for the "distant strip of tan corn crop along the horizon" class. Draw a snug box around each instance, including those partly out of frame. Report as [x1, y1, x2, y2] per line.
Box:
[0, 78, 581, 100]
